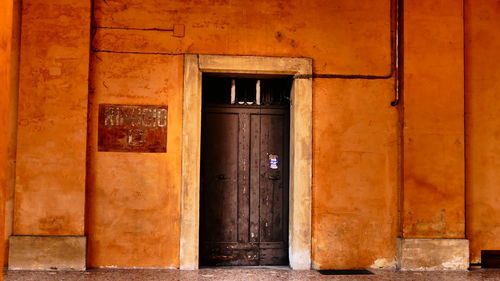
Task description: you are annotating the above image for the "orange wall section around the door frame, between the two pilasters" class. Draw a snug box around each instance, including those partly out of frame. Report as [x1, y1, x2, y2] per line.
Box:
[87, 0, 399, 268]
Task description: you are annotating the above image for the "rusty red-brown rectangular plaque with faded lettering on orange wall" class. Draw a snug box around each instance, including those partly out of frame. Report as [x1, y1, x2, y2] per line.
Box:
[98, 104, 168, 152]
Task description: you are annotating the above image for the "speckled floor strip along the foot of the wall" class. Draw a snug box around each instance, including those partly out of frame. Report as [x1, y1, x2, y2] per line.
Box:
[5, 268, 500, 281]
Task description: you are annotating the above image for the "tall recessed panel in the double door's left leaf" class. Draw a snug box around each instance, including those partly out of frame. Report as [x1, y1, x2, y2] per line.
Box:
[200, 113, 238, 242]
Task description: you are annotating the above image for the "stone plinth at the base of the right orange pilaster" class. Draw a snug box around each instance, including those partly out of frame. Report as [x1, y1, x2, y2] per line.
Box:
[398, 238, 469, 271]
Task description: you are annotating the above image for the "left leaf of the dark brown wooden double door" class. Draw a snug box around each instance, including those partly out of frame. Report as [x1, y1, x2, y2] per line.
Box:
[200, 109, 259, 265]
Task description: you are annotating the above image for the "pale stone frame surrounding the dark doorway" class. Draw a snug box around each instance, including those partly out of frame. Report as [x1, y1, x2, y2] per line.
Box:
[179, 54, 312, 270]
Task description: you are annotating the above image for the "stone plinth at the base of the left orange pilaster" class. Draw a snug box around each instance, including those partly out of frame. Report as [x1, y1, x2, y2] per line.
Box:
[9, 236, 87, 270]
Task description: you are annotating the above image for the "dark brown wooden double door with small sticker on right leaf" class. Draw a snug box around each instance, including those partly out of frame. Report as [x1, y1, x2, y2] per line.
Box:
[200, 105, 289, 266]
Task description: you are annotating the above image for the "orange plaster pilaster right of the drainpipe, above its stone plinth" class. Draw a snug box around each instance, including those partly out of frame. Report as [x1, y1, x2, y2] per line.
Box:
[402, 0, 465, 238]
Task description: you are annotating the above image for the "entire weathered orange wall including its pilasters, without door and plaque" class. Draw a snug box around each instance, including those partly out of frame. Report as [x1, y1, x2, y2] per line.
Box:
[9, 0, 500, 268]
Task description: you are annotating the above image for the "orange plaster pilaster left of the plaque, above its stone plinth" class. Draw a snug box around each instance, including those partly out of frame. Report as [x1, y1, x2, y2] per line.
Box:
[13, 0, 91, 235]
